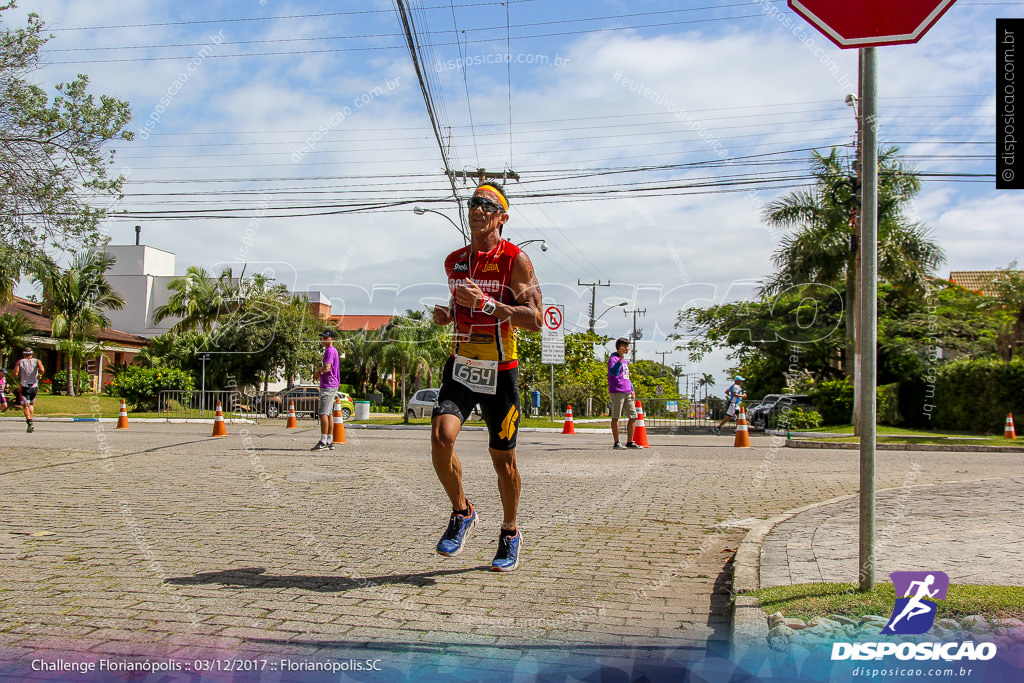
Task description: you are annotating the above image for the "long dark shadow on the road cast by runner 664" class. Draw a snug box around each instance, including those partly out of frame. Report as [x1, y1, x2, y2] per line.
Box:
[167, 565, 490, 593]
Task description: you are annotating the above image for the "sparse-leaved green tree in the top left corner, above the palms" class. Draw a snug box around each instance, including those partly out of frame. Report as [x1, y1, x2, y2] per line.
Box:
[0, 0, 132, 266]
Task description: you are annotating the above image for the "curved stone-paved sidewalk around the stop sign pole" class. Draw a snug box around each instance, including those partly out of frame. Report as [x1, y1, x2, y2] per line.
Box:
[733, 473, 1024, 655]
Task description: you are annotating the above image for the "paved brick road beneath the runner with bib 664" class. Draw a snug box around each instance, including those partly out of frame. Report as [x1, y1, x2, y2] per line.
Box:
[0, 421, 1020, 675]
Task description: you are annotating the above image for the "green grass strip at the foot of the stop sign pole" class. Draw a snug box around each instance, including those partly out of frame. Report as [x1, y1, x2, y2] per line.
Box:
[748, 584, 1024, 621]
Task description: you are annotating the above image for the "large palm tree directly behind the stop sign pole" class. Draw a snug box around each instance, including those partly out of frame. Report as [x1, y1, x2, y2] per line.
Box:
[761, 147, 945, 375]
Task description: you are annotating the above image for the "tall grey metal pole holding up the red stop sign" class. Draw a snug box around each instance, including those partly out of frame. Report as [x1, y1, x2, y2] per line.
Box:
[857, 47, 879, 591]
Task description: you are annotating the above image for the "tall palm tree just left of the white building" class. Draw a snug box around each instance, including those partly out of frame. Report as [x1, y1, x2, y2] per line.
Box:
[33, 250, 125, 396]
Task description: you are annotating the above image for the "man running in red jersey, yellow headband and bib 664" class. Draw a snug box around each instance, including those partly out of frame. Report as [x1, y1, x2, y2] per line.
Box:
[430, 183, 543, 571]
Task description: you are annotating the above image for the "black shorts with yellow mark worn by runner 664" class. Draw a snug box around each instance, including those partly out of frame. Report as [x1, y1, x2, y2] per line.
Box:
[432, 357, 522, 451]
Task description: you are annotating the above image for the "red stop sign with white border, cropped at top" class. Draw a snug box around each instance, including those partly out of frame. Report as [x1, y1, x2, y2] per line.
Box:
[788, 0, 956, 47]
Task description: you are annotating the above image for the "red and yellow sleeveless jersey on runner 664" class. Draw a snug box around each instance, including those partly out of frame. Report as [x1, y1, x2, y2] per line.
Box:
[444, 240, 522, 370]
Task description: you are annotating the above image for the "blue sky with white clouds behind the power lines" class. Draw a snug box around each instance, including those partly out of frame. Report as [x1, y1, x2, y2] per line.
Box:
[4, 0, 1024, 385]
